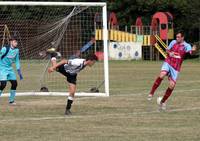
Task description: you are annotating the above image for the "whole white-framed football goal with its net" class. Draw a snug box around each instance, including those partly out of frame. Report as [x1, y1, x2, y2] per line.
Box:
[0, 2, 109, 96]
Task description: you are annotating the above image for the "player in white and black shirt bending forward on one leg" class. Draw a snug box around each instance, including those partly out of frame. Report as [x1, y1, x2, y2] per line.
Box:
[48, 52, 98, 115]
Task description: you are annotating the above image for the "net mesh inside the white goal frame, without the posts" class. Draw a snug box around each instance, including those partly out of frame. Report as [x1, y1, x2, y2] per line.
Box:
[0, 6, 105, 92]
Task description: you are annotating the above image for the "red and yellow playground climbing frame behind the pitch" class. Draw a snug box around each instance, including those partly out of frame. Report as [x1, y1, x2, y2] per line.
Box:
[95, 12, 174, 60]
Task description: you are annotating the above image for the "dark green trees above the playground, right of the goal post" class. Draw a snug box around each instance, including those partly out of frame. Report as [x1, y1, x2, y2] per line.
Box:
[108, 0, 200, 42]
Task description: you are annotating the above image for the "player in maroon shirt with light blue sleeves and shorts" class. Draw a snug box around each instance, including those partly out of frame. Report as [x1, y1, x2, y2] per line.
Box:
[148, 31, 196, 110]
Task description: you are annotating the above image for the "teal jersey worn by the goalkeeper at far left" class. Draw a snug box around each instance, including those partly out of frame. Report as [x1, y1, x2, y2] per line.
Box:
[0, 47, 20, 70]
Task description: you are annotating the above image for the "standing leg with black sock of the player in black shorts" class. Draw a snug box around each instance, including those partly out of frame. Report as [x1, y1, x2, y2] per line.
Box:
[65, 83, 76, 115]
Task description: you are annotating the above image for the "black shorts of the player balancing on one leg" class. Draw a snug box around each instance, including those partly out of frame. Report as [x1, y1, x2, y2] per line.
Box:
[56, 65, 77, 85]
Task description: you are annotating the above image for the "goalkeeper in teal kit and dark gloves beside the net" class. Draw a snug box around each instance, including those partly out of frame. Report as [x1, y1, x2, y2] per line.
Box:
[0, 38, 23, 105]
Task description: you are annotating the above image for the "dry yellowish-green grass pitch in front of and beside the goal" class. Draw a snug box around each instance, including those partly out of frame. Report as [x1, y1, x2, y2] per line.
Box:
[0, 60, 200, 141]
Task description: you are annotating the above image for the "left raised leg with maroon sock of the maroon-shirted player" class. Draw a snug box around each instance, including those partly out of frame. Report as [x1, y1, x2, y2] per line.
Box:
[147, 71, 168, 100]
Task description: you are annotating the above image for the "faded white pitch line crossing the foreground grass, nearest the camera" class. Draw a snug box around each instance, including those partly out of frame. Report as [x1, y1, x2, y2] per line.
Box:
[0, 107, 200, 123]
